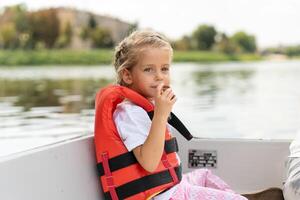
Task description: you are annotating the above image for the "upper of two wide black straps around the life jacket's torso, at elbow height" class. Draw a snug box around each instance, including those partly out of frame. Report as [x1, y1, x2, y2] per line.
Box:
[97, 137, 178, 176]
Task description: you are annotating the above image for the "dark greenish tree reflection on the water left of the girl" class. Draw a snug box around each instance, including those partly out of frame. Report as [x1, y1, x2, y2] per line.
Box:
[0, 79, 112, 113]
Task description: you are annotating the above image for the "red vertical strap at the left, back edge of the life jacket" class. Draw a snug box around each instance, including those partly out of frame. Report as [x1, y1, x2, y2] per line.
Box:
[102, 152, 119, 200]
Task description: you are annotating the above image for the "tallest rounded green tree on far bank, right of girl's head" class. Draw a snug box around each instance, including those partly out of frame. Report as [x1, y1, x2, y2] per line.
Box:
[192, 25, 217, 50]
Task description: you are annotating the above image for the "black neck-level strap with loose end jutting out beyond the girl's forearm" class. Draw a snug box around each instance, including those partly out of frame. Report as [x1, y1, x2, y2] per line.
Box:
[148, 111, 193, 140]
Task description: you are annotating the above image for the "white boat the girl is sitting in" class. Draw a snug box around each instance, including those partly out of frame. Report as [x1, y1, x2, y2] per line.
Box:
[0, 131, 291, 200]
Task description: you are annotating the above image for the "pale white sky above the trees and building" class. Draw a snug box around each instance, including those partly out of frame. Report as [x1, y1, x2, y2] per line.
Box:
[0, 0, 300, 48]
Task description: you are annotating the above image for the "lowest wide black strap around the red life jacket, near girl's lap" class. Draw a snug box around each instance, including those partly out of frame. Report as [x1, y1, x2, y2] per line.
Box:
[104, 165, 182, 200]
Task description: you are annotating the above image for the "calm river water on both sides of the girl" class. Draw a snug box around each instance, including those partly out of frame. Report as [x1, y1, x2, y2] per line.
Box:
[0, 61, 300, 156]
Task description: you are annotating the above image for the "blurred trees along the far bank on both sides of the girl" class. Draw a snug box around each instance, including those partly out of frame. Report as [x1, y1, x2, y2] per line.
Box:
[0, 4, 257, 54]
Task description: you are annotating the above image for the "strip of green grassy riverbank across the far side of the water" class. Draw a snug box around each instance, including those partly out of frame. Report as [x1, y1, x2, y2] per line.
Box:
[0, 49, 262, 66]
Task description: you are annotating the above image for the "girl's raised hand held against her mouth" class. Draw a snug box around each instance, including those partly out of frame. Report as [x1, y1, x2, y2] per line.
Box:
[154, 83, 177, 118]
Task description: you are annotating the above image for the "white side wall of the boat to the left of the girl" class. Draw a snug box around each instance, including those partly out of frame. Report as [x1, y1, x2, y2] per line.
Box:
[0, 136, 104, 200]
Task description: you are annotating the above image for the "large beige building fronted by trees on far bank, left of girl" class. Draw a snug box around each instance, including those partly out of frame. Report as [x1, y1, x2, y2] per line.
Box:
[0, 5, 137, 49]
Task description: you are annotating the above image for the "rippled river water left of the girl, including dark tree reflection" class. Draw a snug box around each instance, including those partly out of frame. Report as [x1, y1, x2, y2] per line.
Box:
[0, 76, 112, 157]
